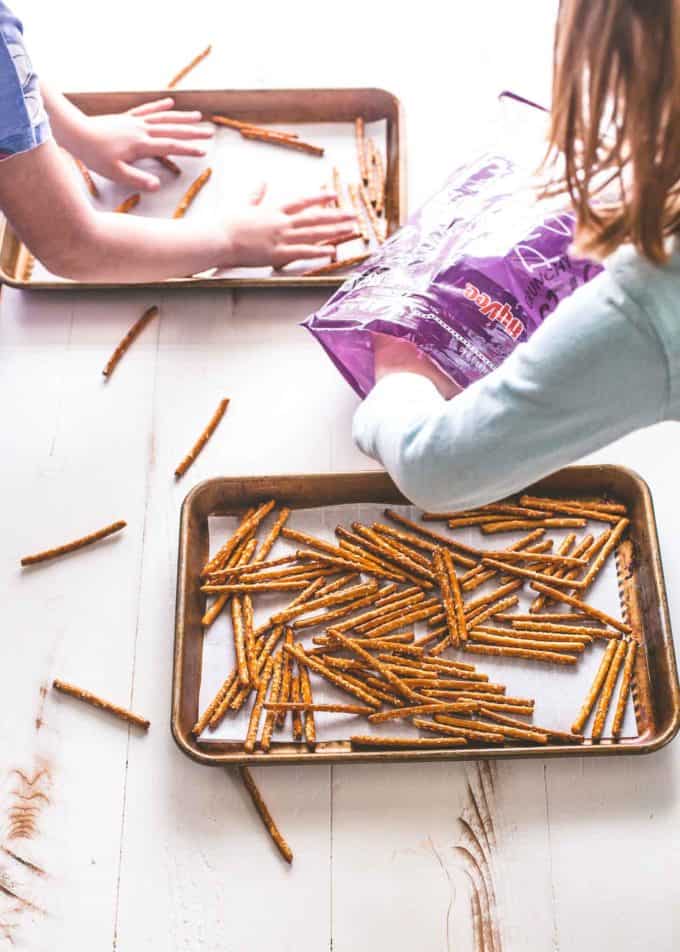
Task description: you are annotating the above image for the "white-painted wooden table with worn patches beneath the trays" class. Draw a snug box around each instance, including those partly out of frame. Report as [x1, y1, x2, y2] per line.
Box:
[0, 0, 680, 952]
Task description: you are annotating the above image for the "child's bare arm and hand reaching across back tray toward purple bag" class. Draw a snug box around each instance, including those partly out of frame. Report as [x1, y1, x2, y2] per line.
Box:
[0, 141, 354, 283]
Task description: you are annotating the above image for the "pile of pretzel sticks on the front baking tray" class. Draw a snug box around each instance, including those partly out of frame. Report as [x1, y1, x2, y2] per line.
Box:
[193, 495, 637, 754]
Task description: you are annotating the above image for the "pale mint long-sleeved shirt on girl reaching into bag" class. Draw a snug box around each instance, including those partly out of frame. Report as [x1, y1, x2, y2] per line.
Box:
[354, 245, 680, 510]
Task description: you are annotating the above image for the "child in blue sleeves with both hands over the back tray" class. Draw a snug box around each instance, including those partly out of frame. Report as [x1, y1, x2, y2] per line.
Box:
[0, 0, 354, 282]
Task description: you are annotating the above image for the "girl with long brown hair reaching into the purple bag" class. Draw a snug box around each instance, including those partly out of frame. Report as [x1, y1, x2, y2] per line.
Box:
[354, 0, 680, 510]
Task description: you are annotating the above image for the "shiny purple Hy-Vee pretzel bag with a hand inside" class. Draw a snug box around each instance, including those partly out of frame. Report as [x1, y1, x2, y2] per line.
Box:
[303, 144, 601, 397]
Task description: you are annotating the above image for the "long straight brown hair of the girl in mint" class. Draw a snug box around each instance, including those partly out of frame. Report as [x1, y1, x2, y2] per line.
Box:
[548, 0, 680, 263]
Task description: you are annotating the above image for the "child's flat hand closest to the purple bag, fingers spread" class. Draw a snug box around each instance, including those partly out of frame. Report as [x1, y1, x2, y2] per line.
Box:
[224, 187, 356, 268]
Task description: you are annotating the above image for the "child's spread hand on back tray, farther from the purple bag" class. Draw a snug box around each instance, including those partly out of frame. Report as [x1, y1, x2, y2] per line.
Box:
[77, 97, 213, 191]
